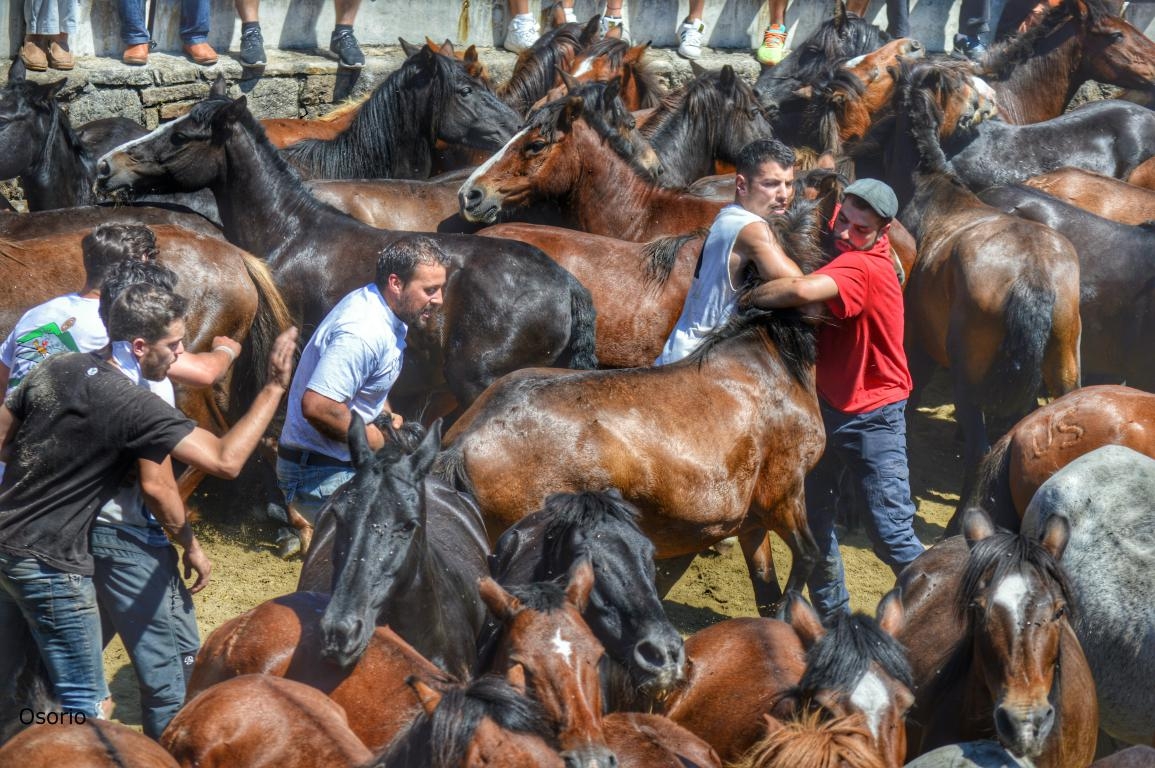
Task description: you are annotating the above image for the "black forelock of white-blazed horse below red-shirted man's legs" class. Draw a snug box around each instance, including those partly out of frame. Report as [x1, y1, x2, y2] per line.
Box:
[798, 613, 915, 700]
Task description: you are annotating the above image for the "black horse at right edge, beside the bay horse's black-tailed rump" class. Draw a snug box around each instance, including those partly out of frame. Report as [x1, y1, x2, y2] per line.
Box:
[978, 185, 1155, 392]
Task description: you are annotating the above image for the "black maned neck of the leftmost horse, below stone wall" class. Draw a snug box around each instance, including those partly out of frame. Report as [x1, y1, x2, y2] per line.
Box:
[21, 104, 96, 210]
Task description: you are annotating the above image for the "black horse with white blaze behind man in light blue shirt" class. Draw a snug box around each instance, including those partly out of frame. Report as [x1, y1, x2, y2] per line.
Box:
[98, 97, 596, 416]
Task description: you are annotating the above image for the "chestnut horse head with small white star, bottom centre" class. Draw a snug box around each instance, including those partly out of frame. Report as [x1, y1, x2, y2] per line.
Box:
[480, 560, 618, 768]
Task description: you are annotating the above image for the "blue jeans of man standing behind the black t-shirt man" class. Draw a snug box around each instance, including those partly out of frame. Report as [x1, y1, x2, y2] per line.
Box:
[91, 523, 201, 739]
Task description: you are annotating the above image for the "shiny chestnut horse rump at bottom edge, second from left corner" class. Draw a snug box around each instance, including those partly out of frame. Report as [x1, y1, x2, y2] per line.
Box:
[159, 674, 373, 768]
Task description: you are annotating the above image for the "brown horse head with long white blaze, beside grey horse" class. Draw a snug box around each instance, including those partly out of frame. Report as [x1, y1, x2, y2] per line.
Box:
[956, 508, 1073, 758]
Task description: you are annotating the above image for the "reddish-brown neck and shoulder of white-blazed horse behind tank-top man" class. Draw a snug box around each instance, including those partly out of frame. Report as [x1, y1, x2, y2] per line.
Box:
[569, 124, 721, 237]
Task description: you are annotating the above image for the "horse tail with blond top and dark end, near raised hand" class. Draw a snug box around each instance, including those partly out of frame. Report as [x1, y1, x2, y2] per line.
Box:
[229, 253, 292, 415]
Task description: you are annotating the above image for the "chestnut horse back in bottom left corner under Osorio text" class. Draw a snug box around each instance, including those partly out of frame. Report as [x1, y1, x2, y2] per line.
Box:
[0, 710, 178, 768]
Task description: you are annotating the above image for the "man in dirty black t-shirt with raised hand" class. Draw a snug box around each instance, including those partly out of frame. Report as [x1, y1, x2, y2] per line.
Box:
[0, 285, 297, 719]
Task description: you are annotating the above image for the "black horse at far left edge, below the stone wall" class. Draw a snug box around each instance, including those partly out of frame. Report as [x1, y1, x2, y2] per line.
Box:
[0, 59, 219, 222]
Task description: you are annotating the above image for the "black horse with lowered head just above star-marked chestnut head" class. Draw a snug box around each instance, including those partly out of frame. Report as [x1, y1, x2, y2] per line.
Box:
[480, 489, 686, 709]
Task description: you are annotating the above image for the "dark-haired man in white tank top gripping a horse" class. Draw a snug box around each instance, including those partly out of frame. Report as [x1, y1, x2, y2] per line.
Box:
[655, 139, 802, 365]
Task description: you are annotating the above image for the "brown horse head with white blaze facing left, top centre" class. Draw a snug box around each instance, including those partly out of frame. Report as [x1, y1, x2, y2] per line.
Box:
[457, 81, 660, 223]
